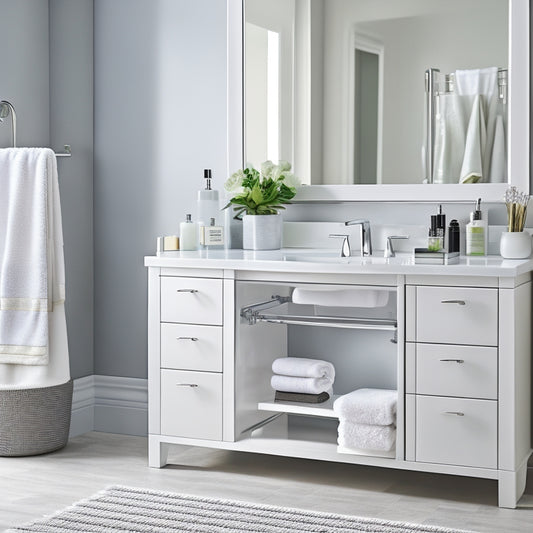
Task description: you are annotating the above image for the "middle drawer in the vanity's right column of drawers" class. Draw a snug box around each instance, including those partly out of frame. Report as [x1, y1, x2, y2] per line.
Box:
[416, 344, 498, 400]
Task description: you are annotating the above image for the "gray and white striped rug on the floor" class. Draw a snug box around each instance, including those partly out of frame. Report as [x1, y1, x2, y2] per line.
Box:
[8, 486, 474, 533]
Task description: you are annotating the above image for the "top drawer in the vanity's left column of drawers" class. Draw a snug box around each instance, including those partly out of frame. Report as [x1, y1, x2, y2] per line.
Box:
[161, 277, 222, 326]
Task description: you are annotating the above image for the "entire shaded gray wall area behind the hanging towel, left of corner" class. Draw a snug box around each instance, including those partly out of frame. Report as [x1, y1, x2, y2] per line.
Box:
[0, 0, 93, 378]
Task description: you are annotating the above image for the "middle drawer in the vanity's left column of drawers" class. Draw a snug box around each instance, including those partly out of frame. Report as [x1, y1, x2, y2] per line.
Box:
[161, 322, 222, 372]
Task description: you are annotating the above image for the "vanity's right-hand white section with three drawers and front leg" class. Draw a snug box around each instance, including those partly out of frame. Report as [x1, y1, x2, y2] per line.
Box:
[405, 275, 531, 507]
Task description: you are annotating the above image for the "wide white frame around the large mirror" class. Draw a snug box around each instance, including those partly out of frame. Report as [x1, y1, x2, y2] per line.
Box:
[227, 0, 530, 203]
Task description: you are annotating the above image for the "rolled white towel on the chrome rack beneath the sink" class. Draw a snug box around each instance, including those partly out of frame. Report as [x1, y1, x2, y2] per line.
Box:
[292, 287, 389, 307]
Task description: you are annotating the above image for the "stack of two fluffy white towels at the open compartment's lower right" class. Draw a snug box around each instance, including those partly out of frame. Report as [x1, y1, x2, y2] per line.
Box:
[333, 389, 398, 452]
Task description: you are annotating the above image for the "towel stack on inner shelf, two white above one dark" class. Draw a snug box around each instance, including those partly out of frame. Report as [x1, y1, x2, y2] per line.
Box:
[270, 357, 335, 403]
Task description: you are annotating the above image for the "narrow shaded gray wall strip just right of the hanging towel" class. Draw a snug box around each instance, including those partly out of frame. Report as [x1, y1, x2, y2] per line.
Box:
[49, 0, 94, 378]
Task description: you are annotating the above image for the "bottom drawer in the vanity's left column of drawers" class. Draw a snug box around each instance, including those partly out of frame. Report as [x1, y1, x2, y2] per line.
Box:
[161, 370, 222, 440]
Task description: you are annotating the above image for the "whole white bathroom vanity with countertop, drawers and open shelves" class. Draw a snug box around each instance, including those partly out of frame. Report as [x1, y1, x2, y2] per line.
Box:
[145, 249, 533, 508]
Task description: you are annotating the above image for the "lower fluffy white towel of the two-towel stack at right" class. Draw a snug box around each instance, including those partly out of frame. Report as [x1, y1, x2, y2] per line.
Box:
[337, 421, 396, 452]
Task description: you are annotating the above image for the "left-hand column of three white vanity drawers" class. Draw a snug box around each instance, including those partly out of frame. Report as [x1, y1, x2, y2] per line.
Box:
[149, 270, 227, 441]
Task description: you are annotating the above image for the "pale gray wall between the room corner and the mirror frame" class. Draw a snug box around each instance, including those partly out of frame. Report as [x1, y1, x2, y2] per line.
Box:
[94, 0, 226, 378]
